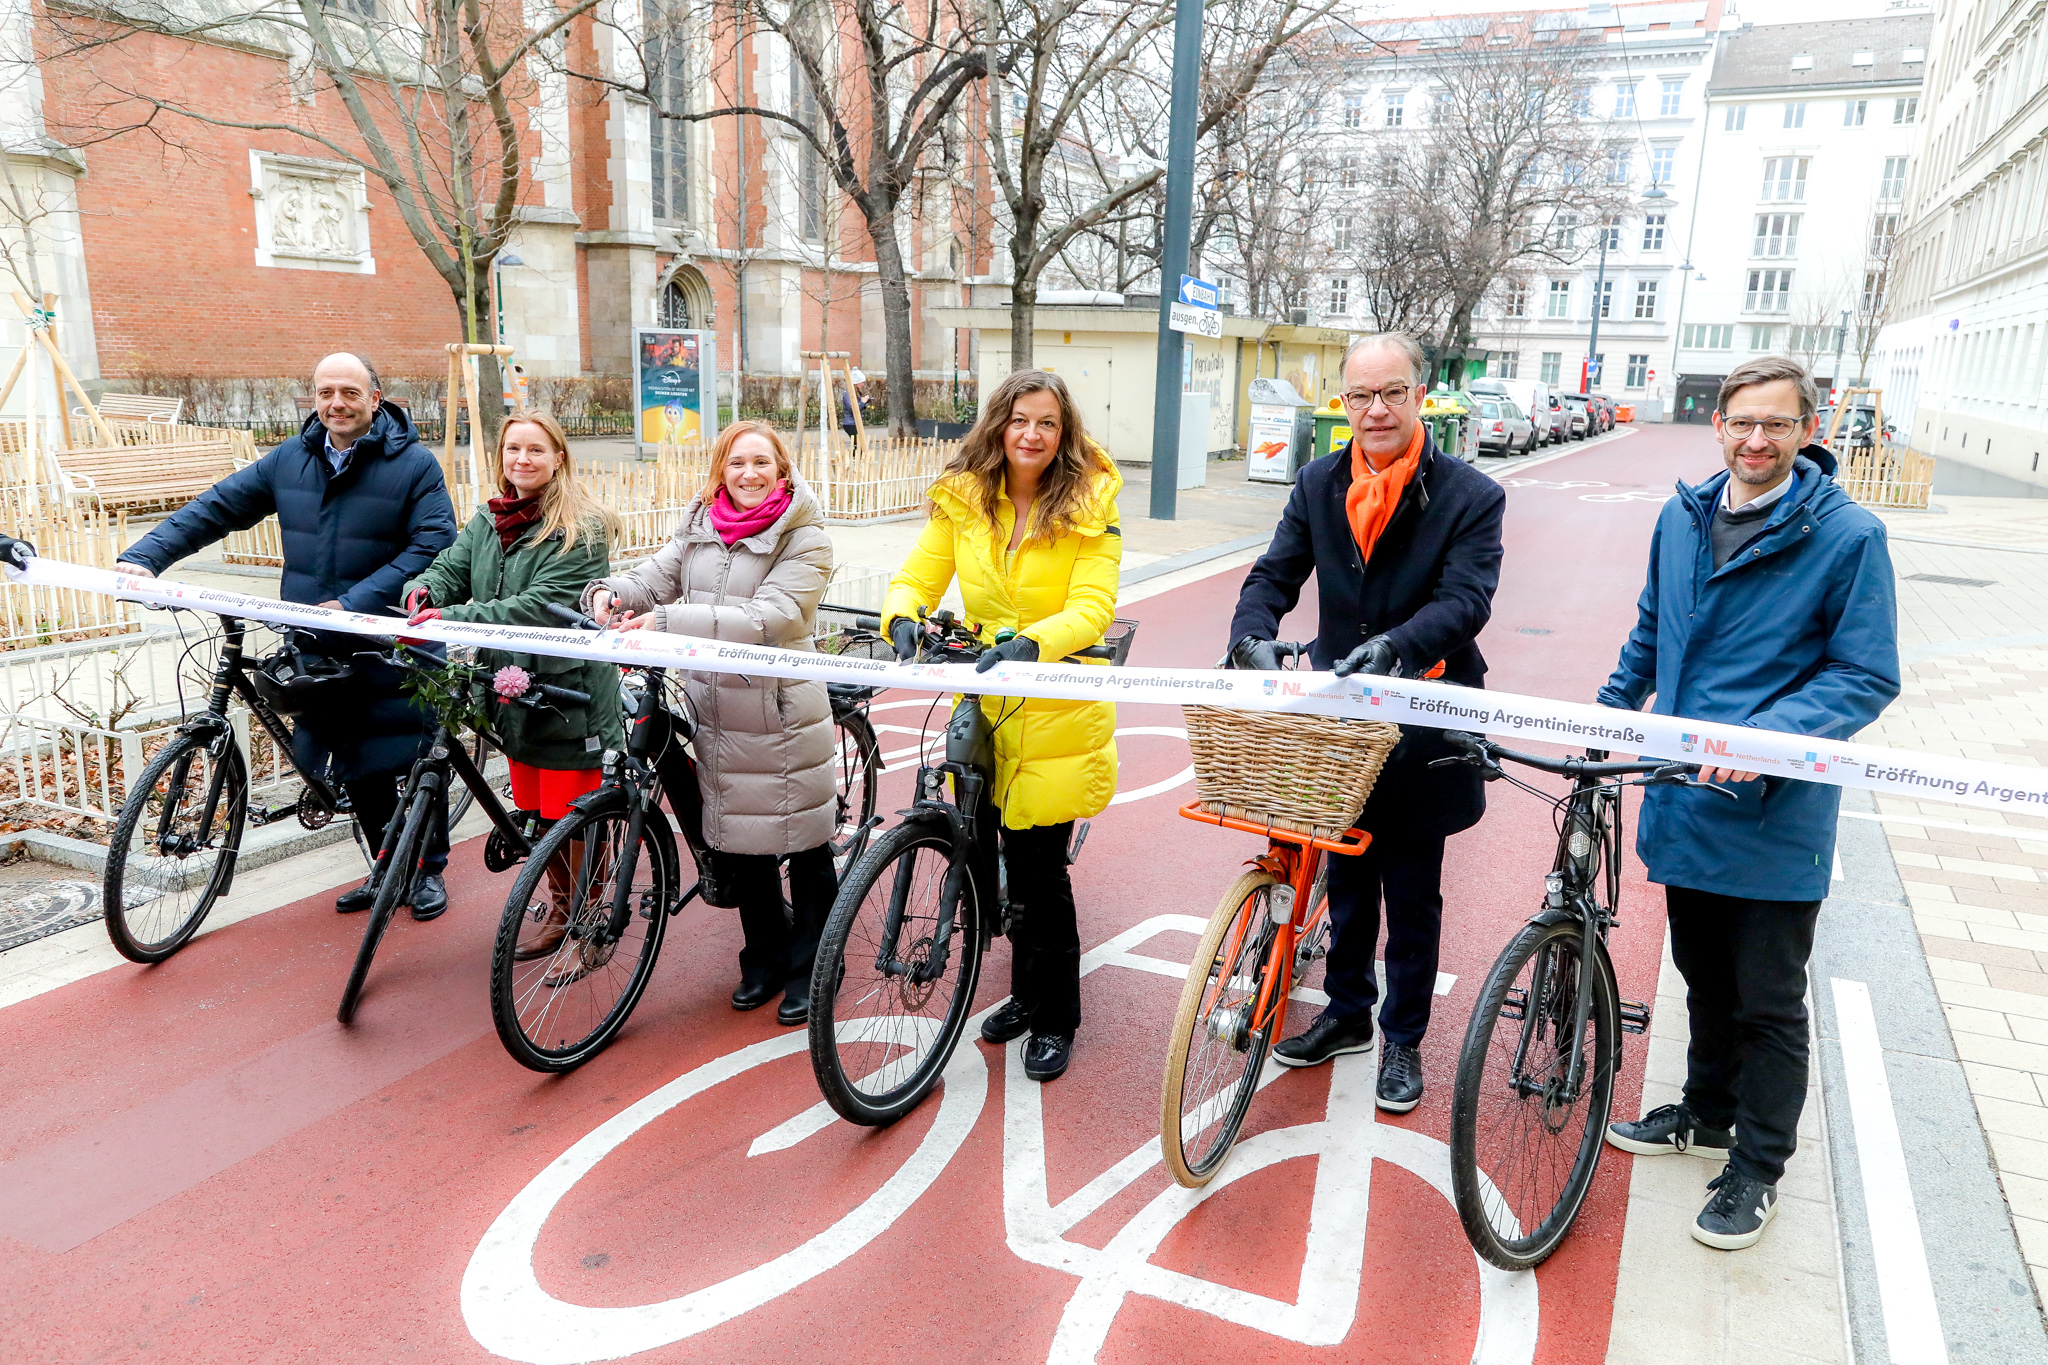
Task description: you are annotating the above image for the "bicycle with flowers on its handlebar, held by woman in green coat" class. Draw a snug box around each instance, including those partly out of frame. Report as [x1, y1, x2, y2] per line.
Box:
[334, 641, 590, 1023]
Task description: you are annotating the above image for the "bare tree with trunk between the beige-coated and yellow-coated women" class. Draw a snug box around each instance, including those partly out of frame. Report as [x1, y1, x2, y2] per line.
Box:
[585, 0, 985, 436]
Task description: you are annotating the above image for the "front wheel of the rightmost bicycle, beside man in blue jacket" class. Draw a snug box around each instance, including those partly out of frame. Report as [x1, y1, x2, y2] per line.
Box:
[1450, 921, 1620, 1271]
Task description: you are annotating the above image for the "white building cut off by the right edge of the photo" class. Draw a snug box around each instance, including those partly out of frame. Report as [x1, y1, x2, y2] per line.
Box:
[1872, 0, 2048, 487]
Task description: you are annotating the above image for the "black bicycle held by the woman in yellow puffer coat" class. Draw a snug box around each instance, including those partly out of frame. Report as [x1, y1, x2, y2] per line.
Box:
[811, 612, 1137, 1128]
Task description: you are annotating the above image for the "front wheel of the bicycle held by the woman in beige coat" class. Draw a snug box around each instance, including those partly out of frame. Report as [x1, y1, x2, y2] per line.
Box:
[492, 806, 676, 1072]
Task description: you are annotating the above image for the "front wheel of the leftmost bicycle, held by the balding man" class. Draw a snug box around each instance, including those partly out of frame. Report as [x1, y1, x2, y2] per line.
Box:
[100, 733, 250, 962]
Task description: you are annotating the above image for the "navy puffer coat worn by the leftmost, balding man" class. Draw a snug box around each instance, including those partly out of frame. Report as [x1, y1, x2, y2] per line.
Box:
[121, 403, 455, 782]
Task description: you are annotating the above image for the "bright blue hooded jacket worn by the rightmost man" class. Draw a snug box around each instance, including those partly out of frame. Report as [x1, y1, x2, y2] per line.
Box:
[1599, 458, 1898, 900]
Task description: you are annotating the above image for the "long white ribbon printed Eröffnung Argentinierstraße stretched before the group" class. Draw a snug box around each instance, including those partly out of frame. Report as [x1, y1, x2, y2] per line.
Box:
[6, 559, 2048, 814]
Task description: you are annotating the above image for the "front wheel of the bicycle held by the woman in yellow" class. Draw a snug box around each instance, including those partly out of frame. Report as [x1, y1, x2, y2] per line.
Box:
[811, 819, 983, 1128]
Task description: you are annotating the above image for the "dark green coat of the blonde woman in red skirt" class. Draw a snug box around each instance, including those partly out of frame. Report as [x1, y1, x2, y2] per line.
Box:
[406, 510, 627, 769]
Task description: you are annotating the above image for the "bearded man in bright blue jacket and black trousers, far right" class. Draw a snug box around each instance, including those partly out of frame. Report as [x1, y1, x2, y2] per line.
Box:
[1599, 356, 1898, 1250]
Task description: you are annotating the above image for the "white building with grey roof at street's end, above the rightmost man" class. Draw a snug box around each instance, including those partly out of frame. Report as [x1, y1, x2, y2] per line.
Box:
[1665, 12, 1933, 422]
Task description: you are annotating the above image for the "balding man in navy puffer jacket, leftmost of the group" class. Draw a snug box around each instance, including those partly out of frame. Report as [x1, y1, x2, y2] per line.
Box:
[119, 352, 455, 919]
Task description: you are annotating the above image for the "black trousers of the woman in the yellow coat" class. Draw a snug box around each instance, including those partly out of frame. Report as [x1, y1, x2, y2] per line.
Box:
[975, 806, 1081, 1033]
